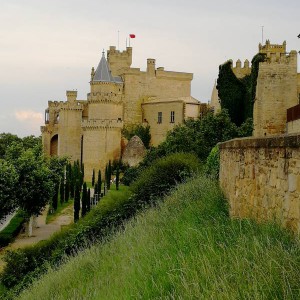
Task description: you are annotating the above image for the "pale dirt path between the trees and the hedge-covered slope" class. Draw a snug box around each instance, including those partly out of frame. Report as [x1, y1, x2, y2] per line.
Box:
[0, 205, 73, 271]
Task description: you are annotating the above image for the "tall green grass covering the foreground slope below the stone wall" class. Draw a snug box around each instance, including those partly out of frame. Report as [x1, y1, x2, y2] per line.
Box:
[18, 176, 300, 300]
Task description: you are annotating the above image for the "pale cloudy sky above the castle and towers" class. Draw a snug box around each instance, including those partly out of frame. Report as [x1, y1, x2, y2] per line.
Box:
[0, 0, 300, 136]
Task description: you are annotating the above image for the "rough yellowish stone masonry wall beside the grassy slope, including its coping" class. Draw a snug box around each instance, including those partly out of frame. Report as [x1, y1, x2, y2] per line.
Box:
[220, 134, 300, 233]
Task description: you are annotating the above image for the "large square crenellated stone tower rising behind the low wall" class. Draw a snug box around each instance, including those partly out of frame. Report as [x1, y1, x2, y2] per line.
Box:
[253, 41, 298, 137]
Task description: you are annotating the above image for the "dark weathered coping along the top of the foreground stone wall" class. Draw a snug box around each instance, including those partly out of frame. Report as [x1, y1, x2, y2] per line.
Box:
[218, 133, 300, 149]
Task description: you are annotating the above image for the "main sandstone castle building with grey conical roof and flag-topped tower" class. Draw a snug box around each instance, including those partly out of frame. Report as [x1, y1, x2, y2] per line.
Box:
[41, 46, 206, 180]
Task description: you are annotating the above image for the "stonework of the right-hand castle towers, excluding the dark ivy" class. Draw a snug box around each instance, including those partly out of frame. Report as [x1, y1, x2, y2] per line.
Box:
[211, 40, 300, 137]
